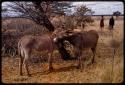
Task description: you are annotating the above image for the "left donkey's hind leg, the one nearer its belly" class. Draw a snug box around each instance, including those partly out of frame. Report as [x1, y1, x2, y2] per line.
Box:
[23, 50, 31, 76]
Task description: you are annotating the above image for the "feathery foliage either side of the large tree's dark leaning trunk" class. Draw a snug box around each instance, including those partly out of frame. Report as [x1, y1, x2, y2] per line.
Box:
[4, 1, 72, 18]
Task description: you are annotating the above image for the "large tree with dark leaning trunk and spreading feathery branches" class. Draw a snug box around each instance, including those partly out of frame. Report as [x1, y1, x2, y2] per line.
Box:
[4, 1, 72, 31]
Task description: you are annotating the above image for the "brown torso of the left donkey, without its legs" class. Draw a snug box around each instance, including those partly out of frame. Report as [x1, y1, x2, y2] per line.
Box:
[19, 35, 53, 51]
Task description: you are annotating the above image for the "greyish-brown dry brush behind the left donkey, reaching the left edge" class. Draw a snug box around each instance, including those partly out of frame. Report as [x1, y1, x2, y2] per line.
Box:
[2, 18, 47, 56]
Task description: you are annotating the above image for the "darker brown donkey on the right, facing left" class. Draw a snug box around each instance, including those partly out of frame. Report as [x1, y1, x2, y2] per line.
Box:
[54, 30, 99, 68]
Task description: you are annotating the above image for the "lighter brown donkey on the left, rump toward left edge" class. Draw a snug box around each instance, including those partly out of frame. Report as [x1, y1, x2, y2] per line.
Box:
[18, 34, 61, 76]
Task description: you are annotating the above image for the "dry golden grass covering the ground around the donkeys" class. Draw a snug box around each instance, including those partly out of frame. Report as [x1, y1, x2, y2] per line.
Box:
[2, 15, 124, 83]
